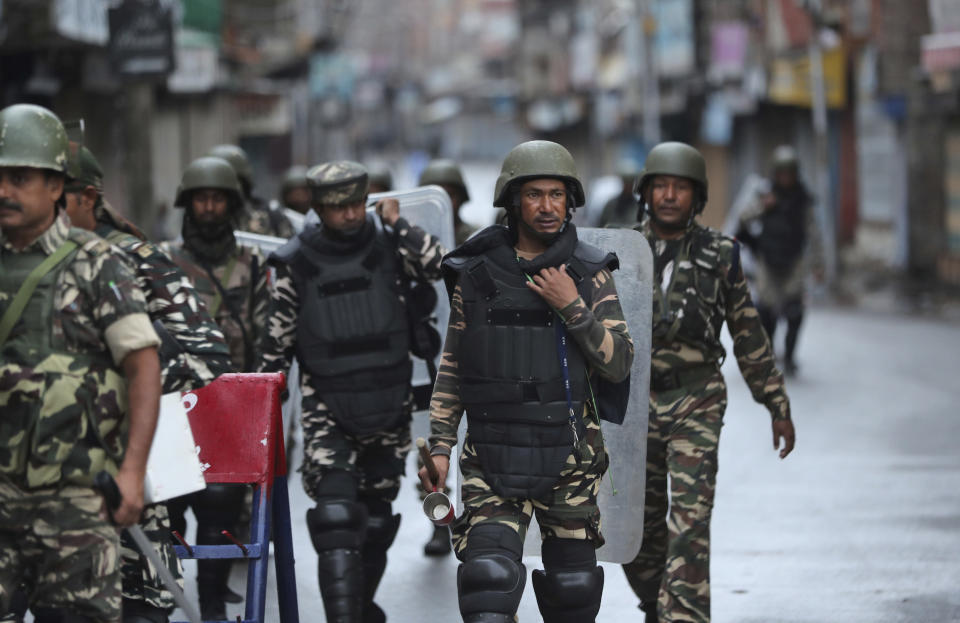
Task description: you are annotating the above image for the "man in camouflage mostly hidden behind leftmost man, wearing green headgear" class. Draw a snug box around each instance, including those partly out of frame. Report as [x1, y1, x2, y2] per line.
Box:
[66, 147, 230, 623]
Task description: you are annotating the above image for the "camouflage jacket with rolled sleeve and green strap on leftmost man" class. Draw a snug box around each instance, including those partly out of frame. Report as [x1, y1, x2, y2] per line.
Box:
[0, 213, 160, 488]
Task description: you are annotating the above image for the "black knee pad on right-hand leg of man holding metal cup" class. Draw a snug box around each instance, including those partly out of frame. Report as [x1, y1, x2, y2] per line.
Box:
[533, 539, 603, 623]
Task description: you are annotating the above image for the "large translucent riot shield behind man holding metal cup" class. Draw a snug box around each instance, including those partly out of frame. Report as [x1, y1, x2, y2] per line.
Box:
[456, 227, 653, 564]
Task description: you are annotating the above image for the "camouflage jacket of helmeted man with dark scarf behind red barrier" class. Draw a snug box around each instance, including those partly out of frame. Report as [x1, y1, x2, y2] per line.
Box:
[160, 242, 270, 372]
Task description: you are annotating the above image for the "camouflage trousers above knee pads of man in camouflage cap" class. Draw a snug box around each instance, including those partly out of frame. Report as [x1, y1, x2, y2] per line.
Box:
[300, 383, 413, 502]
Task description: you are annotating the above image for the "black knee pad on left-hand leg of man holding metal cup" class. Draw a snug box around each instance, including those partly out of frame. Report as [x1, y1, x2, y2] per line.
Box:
[457, 524, 527, 621]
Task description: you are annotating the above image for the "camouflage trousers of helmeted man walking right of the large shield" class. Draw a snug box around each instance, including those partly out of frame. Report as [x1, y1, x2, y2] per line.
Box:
[623, 373, 727, 623]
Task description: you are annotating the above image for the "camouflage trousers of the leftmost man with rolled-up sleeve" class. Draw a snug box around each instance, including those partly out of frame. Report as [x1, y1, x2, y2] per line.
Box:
[0, 479, 120, 623]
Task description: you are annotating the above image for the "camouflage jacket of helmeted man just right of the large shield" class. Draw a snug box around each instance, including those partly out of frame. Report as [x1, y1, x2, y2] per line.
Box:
[637, 218, 790, 420]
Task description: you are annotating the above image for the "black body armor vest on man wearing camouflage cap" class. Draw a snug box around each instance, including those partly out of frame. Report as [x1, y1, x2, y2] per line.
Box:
[271, 217, 413, 435]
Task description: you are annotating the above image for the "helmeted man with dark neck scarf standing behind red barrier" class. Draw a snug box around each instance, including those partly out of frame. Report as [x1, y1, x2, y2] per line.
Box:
[161, 157, 270, 619]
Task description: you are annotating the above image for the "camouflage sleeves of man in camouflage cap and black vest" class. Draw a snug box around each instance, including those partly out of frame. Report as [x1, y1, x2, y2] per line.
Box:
[260, 217, 446, 376]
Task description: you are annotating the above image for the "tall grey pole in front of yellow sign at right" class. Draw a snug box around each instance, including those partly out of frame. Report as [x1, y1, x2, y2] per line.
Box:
[806, 0, 837, 286]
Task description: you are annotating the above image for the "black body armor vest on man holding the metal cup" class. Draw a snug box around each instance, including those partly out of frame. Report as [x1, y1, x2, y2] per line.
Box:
[443, 227, 617, 498]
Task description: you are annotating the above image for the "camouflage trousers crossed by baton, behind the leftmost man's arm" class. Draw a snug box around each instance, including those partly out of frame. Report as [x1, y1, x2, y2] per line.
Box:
[120, 504, 183, 610]
